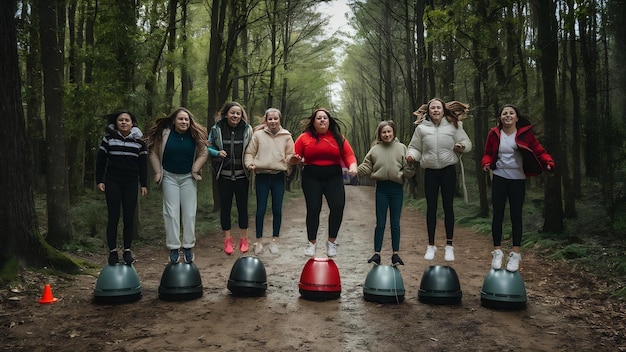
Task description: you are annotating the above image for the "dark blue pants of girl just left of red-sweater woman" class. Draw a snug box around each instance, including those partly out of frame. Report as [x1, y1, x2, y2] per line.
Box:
[255, 172, 285, 238]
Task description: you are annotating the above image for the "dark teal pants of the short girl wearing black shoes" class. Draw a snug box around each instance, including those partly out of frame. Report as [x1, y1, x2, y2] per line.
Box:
[374, 181, 404, 252]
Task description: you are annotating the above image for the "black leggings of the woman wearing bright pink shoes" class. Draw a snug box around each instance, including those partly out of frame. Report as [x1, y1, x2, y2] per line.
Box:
[217, 176, 250, 231]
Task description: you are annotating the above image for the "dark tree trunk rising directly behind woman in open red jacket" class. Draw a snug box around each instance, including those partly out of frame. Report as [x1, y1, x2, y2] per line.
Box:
[531, 0, 564, 233]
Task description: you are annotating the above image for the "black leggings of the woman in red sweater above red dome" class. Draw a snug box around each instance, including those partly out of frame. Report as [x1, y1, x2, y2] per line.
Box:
[302, 165, 346, 241]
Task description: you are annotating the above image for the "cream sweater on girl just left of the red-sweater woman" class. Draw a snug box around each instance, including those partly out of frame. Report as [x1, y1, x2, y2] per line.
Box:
[244, 127, 293, 173]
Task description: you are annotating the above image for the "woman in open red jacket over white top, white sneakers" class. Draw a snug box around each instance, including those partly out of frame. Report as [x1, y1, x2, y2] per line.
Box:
[482, 104, 554, 272]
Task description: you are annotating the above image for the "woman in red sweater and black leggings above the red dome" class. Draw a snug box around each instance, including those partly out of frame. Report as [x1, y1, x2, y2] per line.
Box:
[290, 108, 357, 257]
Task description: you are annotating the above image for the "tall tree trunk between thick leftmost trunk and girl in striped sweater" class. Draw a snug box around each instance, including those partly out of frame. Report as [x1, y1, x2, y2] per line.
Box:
[39, 0, 72, 248]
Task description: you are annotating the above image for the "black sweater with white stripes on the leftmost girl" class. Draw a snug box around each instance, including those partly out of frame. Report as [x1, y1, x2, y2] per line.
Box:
[96, 124, 148, 187]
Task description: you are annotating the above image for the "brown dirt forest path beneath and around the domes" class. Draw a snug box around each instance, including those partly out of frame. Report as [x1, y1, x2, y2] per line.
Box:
[0, 186, 626, 352]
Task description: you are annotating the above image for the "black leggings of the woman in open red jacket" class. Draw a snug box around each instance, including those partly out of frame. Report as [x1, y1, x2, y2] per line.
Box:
[491, 175, 526, 247]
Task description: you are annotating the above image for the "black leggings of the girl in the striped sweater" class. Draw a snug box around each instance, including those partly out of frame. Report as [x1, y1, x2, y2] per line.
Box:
[104, 179, 138, 250]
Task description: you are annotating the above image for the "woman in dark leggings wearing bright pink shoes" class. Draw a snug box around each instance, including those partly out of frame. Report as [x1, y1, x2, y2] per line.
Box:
[209, 101, 252, 255]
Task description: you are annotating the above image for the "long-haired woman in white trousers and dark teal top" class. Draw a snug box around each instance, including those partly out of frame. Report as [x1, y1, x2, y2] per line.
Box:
[147, 107, 208, 263]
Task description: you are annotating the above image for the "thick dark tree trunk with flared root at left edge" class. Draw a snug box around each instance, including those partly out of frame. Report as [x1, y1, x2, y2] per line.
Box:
[0, 1, 78, 274]
